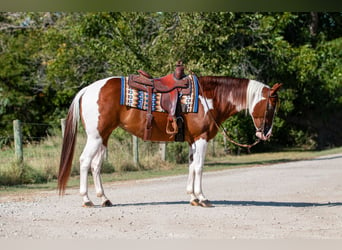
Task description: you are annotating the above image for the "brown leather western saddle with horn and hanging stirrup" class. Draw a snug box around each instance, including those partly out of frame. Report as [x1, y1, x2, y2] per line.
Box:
[128, 61, 191, 141]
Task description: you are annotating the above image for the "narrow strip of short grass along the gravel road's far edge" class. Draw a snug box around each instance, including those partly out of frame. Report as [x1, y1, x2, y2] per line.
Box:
[0, 148, 342, 195]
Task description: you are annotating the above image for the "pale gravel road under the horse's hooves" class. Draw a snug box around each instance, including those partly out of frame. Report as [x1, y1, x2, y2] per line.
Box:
[0, 154, 342, 239]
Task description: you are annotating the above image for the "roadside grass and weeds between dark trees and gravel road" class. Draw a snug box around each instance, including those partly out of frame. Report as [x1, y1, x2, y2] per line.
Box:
[0, 129, 342, 193]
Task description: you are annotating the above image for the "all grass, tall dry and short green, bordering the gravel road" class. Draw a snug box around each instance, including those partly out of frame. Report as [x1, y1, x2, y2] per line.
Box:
[0, 136, 342, 195]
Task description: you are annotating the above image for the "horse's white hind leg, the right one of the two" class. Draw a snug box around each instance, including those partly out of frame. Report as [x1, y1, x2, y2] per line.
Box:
[91, 144, 112, 207]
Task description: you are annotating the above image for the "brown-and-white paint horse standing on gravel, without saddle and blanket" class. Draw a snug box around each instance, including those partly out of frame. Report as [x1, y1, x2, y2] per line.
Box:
[58, 66, 282, 207]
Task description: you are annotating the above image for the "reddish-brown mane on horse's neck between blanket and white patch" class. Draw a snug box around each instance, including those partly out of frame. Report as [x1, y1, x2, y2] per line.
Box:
[199, 76, 249, 112]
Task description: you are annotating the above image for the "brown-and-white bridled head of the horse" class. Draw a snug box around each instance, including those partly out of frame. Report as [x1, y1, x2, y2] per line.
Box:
[250, 83, 282, 141]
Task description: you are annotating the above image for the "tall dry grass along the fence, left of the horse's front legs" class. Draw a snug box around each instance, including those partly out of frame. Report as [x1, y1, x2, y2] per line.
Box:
[0, 131, 179, 188]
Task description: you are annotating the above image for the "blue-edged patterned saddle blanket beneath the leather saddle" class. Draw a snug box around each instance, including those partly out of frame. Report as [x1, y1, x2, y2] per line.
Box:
[120, 75, 198, 113]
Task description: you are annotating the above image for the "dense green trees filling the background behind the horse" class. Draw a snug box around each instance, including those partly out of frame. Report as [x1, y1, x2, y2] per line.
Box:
[0, 12, 342, 151]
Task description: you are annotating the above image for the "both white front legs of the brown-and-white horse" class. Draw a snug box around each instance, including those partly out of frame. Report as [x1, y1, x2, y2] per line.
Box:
[187, 139, 212, 207]
